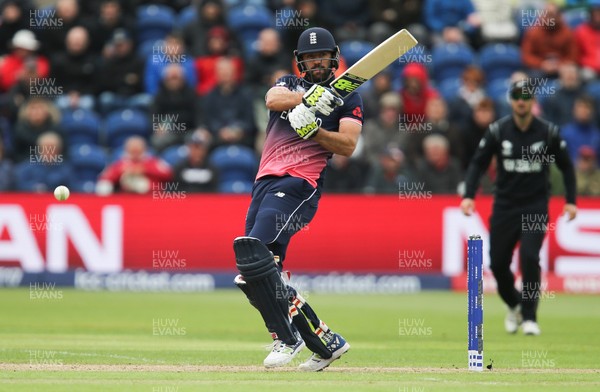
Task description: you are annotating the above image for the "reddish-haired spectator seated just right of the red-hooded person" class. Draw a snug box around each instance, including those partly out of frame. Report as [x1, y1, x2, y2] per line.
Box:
[448, 65, 485, 126]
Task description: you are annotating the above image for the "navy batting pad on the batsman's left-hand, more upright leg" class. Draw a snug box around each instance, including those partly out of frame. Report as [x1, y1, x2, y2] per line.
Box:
[233, 237, 297, 344]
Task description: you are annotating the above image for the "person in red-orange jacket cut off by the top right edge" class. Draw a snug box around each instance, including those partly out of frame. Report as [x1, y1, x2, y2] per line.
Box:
[575, 0, 600, 80]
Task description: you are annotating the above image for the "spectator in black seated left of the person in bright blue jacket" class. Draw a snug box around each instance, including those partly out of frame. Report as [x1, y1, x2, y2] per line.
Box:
[99, 29, 152, 114]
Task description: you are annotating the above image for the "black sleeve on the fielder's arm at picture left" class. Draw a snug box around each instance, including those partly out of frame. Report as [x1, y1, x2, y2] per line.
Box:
[463, 123, 500, 199]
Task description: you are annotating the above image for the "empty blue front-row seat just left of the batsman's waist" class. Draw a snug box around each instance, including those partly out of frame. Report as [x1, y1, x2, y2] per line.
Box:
[209, 145, 258, 193]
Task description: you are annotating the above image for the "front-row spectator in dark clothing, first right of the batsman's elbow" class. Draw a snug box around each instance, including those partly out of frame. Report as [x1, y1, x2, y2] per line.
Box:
[364, 147, 410, 194]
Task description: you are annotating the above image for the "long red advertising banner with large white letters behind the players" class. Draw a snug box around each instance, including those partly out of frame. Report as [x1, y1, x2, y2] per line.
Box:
[0, 194, 600, 276]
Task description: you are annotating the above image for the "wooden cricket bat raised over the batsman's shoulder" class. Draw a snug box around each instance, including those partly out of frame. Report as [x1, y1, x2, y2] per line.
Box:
[329, 29, 418, 98]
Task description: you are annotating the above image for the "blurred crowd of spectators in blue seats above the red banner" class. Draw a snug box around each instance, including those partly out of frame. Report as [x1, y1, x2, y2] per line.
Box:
[0, 0, 600, 195]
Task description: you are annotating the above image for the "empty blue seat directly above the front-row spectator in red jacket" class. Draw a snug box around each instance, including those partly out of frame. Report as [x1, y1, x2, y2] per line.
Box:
[104, 109, 152, 148]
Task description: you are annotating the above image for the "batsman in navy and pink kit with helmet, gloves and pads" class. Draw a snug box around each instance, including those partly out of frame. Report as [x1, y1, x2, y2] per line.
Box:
[233, 27, 363, 371]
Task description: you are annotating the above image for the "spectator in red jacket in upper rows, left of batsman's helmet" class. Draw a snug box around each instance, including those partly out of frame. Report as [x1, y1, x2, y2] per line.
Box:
[195, 27, 244, 96]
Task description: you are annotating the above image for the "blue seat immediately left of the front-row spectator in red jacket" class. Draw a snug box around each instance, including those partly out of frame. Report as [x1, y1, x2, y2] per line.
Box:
[69, 144, 107, 193]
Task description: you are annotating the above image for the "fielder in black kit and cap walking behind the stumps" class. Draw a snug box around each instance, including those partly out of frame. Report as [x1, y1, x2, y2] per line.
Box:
[461, 80, 577, 335]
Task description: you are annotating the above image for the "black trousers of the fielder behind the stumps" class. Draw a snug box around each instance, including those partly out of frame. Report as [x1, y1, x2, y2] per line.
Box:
[490, 199, 548, 321]
